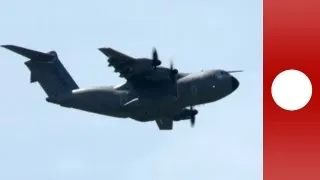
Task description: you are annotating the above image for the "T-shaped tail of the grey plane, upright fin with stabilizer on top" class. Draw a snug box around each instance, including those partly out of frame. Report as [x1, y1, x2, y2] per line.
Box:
[2, 45, 79, 100]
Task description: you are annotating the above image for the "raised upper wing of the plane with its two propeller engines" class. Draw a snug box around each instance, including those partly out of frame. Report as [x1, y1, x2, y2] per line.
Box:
[99, 45, 179, 97]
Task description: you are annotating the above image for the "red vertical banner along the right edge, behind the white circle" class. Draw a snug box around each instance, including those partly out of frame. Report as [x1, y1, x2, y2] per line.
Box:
[263, 0, 320, 180]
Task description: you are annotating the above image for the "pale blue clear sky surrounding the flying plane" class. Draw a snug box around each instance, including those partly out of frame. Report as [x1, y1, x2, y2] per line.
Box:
[0, 0, 262, 180]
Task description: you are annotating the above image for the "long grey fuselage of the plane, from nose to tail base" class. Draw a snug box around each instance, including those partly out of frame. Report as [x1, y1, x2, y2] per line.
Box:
[53, 70, 239, 122]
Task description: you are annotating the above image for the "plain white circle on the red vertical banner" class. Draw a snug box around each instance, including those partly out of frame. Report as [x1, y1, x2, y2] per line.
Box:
[271, 69, 312, 111]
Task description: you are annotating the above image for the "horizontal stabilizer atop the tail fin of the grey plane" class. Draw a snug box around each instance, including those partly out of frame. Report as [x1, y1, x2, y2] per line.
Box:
[2, 45, 55, 61]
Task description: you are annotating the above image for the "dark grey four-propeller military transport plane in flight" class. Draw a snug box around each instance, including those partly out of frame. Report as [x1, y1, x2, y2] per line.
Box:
[2, 45, 241, 130]
